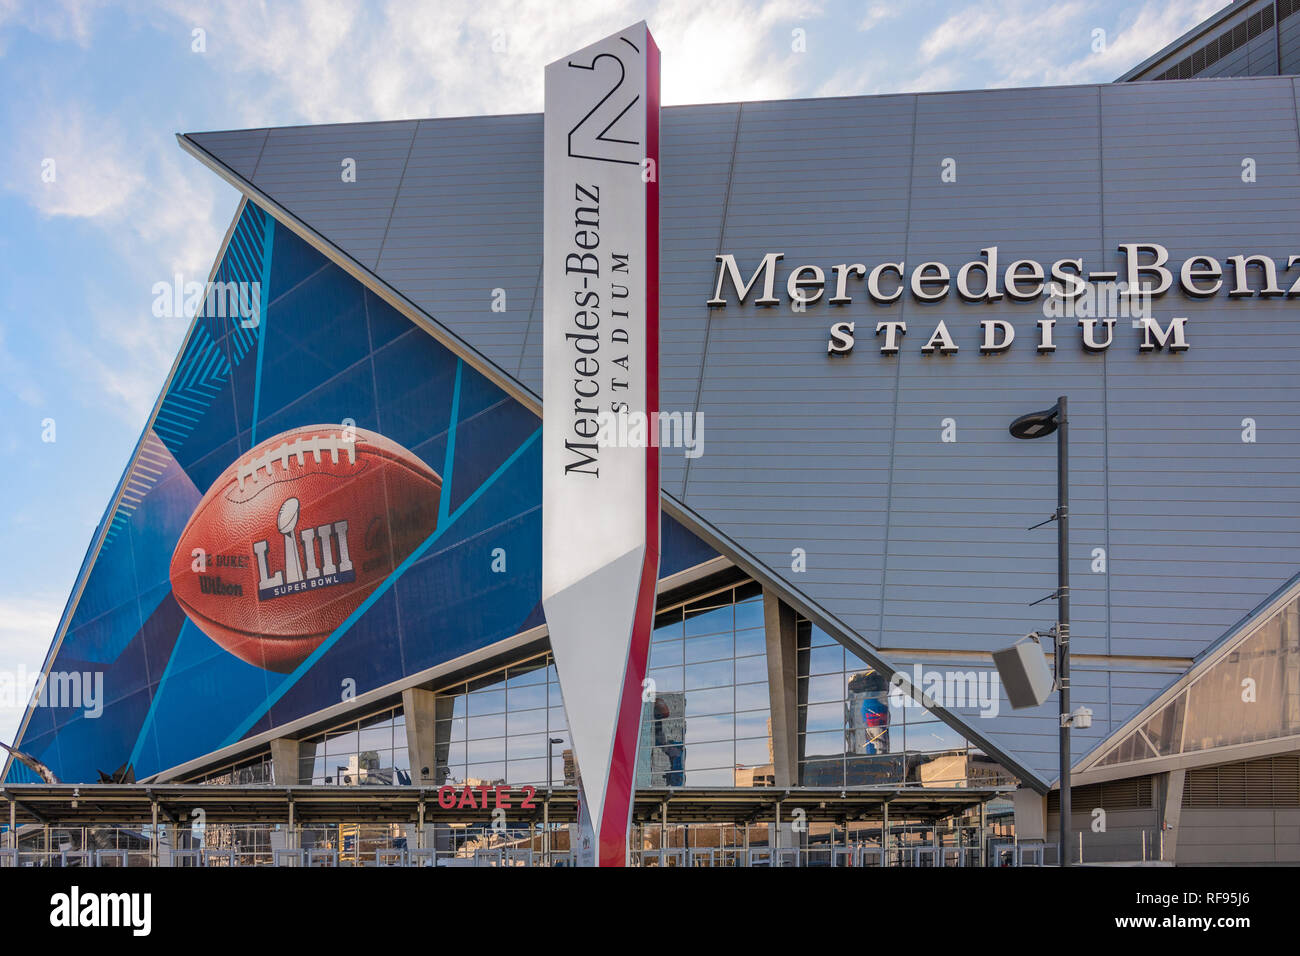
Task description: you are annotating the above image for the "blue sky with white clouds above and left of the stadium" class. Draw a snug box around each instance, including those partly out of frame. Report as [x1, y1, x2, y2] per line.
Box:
[0, 0, 1226, 743]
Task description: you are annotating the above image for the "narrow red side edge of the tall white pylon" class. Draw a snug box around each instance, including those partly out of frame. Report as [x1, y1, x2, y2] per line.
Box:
[597, 30, 659, 866]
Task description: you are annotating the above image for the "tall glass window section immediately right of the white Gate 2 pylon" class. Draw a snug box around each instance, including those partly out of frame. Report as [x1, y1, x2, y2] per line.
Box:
[637, 581, 772, 787]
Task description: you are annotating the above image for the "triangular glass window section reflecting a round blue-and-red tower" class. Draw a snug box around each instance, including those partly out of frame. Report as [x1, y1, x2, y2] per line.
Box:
[796, 618, 1005, 787]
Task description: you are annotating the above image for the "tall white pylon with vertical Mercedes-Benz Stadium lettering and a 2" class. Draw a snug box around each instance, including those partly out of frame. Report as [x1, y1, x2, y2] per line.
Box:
[542, 22, 659, 866]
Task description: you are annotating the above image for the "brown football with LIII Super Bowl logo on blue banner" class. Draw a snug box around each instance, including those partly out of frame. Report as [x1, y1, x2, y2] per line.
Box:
[170, 425, 442, 672]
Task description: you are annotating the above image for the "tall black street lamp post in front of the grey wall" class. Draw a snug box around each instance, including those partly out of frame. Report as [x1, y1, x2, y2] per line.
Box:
[1010, 395, 1073, 866]
